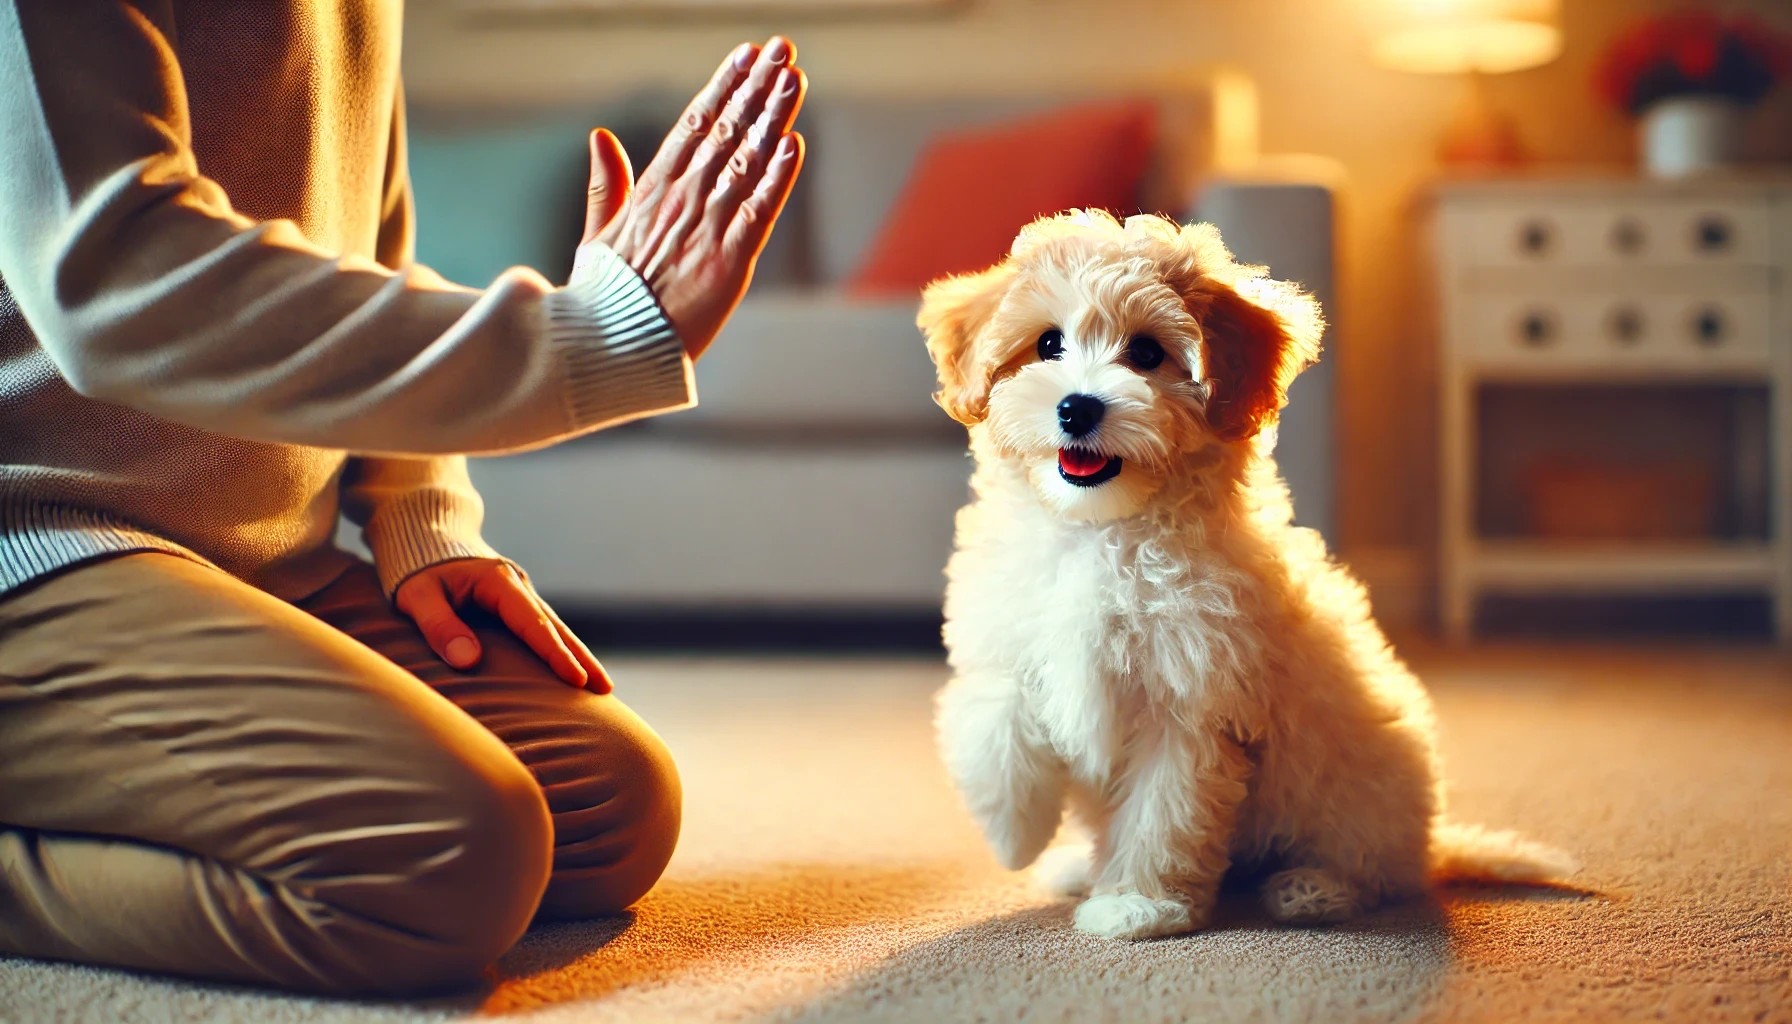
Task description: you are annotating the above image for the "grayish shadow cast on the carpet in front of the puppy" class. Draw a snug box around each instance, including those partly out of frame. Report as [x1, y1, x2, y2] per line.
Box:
[778, 888, 1591, 1022]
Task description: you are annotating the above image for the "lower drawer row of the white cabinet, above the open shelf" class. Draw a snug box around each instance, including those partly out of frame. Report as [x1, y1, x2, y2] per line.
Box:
[1464, 291, 1770, 373]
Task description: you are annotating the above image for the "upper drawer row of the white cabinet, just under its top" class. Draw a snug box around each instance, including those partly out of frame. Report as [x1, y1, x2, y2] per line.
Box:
[1469, 197, 1772, 267]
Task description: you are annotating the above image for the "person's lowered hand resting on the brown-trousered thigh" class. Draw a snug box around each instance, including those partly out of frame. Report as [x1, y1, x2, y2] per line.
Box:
[392, 558, 611, 694]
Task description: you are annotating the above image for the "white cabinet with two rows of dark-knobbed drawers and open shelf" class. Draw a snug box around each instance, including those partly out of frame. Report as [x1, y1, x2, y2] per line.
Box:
[1434, 176, 1792, 638]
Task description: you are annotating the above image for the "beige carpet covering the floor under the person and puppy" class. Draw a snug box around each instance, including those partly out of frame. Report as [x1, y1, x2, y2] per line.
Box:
[0, 649, 1792, 1024]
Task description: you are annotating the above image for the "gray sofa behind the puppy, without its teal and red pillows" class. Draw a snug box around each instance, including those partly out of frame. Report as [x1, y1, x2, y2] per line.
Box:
[412, 90, 1331, 620]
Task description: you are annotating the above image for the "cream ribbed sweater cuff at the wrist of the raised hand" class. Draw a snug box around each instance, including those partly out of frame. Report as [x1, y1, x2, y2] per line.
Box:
[547, 242, 697, 430]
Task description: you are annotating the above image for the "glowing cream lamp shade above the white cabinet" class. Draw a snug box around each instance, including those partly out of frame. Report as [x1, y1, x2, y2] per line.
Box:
[1371, 0, 1563, 75]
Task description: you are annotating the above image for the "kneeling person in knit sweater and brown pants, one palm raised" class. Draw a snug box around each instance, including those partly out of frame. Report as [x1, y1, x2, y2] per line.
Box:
[0, 0, 806, 994]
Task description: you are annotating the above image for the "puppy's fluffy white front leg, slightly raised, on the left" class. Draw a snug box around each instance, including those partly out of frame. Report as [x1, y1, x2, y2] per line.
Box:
[934, 674, 1068, 870]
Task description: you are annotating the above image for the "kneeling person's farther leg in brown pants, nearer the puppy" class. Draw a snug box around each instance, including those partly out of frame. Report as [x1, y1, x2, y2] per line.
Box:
[301, 567, 681, 918]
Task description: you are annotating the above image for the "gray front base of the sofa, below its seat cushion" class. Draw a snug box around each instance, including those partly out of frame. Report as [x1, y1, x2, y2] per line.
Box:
[470, 430, 971, 612]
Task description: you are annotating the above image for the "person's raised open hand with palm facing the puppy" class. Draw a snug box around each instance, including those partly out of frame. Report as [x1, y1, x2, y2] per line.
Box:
[584, 36, 808, 359]
